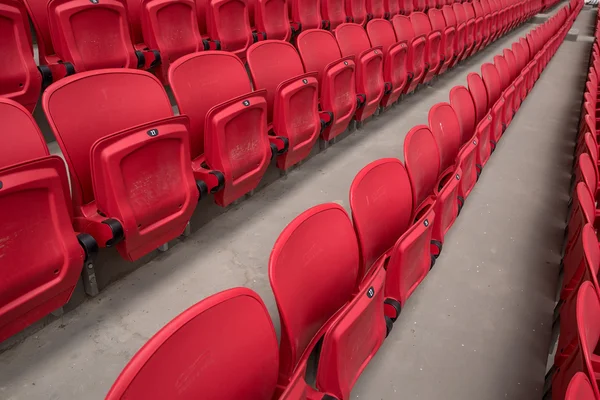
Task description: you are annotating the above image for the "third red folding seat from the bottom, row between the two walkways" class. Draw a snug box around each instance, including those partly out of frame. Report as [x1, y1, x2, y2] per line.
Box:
[350, 158, 435, 321]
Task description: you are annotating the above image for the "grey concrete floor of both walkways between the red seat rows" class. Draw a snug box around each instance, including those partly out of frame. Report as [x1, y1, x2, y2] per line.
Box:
[0, 4, 596, 400]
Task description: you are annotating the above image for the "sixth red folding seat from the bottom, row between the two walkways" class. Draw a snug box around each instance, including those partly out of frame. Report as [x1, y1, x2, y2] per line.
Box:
[450, 86, 482, 201]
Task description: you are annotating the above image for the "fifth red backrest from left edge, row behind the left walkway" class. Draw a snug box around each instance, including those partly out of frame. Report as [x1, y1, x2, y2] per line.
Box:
[296, 29, 342, 83]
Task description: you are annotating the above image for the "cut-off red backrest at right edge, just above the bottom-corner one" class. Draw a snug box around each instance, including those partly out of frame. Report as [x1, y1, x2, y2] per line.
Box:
[575, 281, 600, 393]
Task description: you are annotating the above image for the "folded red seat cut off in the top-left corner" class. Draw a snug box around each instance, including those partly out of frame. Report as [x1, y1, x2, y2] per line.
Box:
[0, 0, 42, 112]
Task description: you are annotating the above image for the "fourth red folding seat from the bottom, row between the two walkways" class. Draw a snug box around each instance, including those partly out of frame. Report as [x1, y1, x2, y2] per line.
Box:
[404, 125, 462, 256]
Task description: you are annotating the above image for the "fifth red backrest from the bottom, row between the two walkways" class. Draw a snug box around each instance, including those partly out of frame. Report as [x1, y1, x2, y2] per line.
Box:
[428, 103, 461, 171]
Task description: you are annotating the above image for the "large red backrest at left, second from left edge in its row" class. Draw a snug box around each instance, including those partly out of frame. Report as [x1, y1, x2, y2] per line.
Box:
[42, 69, 173, 205]
